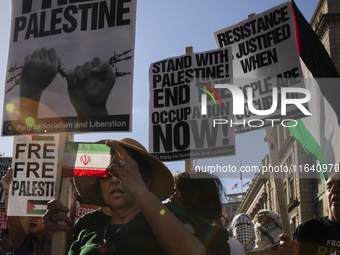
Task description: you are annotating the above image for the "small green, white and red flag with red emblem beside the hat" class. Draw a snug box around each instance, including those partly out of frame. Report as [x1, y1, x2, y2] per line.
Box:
[61, 142, 111, 178]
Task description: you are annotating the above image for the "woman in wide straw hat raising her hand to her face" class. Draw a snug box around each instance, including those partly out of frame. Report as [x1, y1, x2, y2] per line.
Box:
[44, 138, 205, 255]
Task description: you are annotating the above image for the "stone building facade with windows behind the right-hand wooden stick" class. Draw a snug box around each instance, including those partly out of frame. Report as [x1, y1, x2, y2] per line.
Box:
[237, 130, 327, 230]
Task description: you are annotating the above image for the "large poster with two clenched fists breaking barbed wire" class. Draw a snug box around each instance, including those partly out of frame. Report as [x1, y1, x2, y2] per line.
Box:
[2, 0, 137, 136]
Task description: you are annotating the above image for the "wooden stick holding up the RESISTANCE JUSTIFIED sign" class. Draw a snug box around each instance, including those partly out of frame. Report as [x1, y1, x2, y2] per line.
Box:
[266, 127, 292, 240]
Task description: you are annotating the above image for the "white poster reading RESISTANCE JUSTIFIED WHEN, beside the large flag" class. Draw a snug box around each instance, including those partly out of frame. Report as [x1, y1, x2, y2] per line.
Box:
[214, 1, 304, 133]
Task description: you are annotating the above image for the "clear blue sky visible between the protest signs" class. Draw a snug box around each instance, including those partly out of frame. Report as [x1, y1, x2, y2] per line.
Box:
[0, 0, 318, 198]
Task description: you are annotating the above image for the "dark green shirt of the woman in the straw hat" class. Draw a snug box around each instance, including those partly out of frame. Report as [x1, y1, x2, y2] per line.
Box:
[68, 203, 196, 255]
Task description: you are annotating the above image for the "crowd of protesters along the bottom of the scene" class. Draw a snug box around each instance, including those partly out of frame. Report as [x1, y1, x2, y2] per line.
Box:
[1, 138, 340, 255]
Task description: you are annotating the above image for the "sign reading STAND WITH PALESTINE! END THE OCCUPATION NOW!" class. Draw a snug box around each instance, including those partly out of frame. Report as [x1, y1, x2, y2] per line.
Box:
[149, 48, 235, 161]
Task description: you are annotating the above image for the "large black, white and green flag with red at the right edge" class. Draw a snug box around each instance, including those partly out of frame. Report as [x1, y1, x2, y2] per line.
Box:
[289, 2, 340, 187]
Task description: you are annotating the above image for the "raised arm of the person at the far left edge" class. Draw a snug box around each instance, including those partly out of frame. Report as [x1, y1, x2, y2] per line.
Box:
[1, 168, 25, 251]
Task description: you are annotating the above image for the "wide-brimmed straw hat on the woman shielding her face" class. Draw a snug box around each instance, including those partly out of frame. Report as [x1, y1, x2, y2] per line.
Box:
[74, 138, 174, 206]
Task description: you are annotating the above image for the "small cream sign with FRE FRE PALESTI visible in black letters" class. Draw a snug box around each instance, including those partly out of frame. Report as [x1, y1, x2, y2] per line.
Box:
[7, 135, 59, 216]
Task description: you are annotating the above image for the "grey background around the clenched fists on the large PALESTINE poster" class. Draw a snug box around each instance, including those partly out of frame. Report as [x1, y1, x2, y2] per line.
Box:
[3, 0, 137, 135]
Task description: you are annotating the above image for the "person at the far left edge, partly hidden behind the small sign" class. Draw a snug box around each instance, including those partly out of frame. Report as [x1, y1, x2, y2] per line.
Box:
[1, 168, 45, 255]
